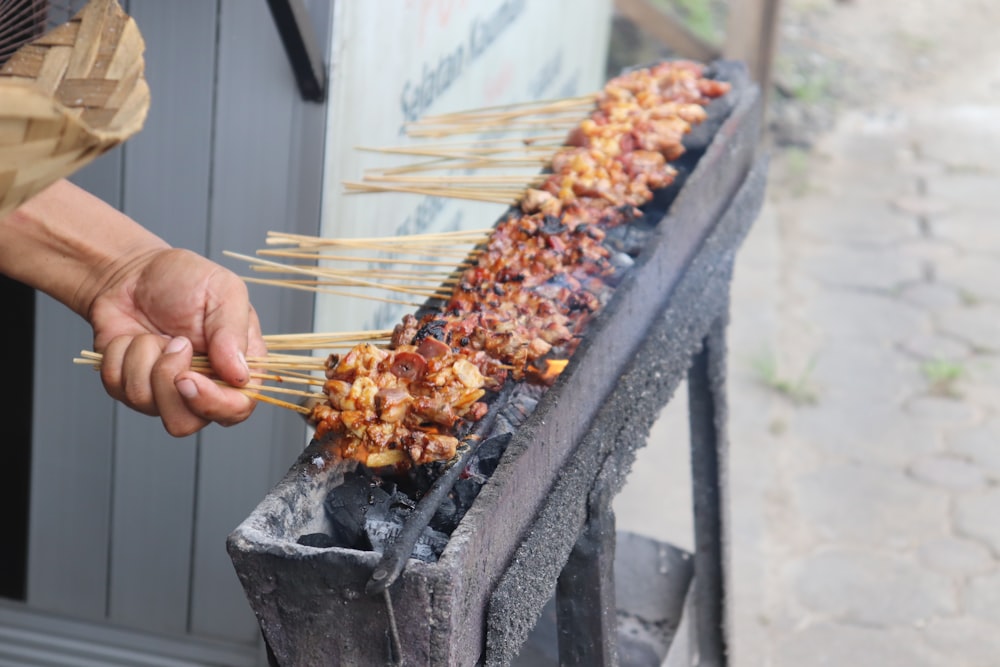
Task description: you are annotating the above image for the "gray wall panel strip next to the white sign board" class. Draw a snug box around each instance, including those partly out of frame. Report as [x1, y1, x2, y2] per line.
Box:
[191, 0, 318, 640]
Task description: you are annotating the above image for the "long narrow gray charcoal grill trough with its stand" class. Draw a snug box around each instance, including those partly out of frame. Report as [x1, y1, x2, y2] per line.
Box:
[227, 62, 766, 667]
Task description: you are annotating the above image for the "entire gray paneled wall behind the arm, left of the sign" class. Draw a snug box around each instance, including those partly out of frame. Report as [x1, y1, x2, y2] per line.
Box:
[22, 0, 332, 655]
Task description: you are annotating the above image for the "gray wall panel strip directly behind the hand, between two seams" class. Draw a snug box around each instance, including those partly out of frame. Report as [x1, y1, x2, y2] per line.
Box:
[109, 0, 217, 633]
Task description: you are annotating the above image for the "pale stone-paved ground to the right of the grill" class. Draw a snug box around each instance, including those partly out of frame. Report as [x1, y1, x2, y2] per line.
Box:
[616, 0, 1000, 667]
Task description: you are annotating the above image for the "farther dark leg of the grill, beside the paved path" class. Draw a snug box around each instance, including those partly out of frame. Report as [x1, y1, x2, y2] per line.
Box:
[688, 316, 727, 667]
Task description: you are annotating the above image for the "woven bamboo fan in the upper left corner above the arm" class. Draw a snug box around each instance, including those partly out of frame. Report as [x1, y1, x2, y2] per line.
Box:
[0, 0, 149, 216]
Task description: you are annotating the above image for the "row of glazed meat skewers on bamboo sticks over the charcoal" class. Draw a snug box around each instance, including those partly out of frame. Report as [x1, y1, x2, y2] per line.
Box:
[81, 61, 728, 468]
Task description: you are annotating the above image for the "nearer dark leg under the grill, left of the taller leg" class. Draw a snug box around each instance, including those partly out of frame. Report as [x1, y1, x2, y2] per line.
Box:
[556, 489, 618, 667]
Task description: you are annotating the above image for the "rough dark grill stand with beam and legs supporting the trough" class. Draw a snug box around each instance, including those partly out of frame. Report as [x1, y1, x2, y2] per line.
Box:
[485, 158, 766, 667]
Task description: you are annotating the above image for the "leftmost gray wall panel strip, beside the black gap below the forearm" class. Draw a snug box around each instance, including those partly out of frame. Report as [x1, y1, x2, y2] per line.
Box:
[27, 149, 122, 619]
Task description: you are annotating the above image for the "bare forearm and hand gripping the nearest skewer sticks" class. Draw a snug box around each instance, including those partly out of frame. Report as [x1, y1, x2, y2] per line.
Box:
[0, 181, 266, 436]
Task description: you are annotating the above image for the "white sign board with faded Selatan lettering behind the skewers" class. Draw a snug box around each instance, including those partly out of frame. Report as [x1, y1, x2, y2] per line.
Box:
[315, 0, 611, 332]
